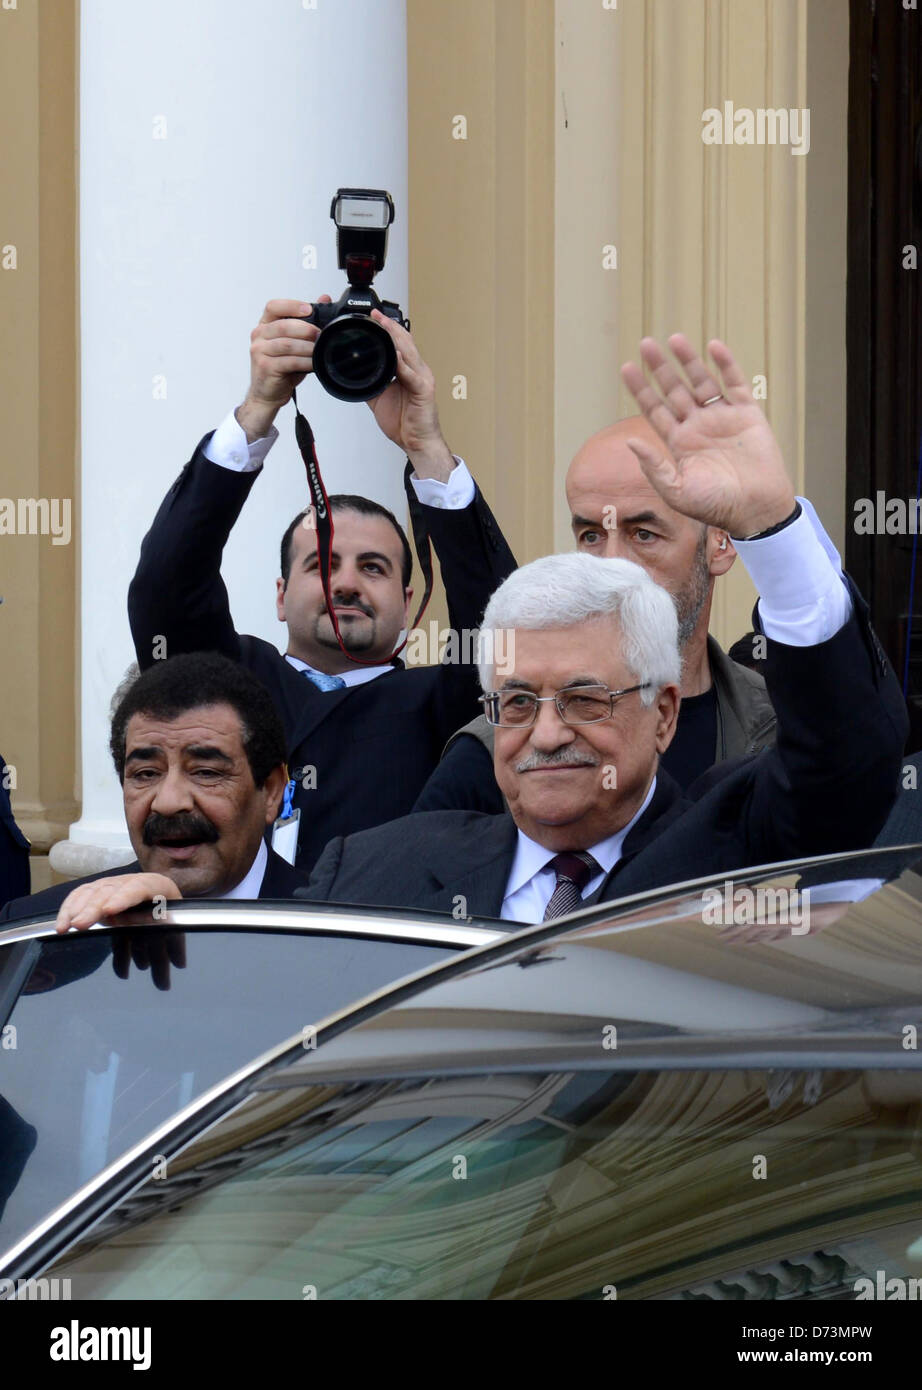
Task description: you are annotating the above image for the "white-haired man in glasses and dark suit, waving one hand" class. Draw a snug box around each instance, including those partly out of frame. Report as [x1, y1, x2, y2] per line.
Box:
[304, 335, 908, 923]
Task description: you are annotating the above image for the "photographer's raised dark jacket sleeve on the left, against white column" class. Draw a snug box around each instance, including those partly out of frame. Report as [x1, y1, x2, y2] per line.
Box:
[128, 435, 259, 670]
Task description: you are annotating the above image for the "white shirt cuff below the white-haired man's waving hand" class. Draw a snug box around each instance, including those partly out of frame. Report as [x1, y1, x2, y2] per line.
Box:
[733, 498, 851, 646]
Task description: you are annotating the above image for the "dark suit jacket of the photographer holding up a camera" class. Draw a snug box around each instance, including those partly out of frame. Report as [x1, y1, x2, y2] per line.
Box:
[128, 435, 516, 870]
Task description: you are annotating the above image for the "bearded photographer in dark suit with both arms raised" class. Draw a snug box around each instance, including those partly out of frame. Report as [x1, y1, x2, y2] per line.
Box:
[128, 296, 515, 869]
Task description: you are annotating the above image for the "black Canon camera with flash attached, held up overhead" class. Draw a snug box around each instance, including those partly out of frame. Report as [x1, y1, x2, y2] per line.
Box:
[305, 188, 410, 400]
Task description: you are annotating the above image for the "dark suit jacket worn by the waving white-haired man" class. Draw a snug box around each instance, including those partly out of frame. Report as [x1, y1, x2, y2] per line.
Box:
[298, 588, 908, 916]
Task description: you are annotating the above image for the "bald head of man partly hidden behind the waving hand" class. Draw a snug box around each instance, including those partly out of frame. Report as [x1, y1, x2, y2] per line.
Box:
[566, 416, 736, 644]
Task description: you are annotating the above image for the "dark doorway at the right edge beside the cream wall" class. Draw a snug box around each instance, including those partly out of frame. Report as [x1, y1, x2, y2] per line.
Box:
[846, 0, 922, 752]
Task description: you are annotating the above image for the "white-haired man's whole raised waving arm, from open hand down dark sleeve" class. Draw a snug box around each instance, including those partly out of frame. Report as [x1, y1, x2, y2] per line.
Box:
[622, 334, 908, 863]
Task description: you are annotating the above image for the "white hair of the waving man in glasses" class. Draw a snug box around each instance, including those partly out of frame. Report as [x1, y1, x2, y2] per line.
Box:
[477, 550, 681, 705]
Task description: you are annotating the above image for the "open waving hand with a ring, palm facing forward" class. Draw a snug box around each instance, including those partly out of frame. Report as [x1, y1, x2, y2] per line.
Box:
[622, 334, 795, 539]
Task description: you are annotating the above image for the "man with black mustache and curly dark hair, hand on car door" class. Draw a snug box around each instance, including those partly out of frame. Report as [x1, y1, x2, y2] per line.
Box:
[0, 652, 306, 931]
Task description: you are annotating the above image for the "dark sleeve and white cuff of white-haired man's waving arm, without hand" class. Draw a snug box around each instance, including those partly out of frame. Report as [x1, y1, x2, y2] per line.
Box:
[737, 503, 908, 863]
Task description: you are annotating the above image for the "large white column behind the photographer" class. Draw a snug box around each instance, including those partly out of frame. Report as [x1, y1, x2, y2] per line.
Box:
[51, 0, 409, 874]
